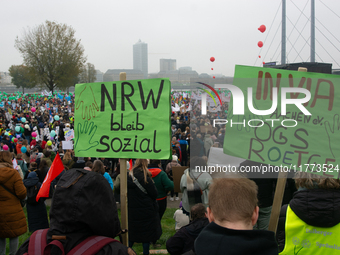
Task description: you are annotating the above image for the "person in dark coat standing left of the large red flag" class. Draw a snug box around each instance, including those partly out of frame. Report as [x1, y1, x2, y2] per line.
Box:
[24, 171, 49, 232]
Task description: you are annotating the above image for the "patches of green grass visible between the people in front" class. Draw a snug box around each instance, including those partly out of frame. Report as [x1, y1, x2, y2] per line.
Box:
[6, 206, 177, 254]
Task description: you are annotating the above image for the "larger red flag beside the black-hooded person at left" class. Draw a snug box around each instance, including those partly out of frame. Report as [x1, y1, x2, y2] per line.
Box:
[36, 153, 64, 202]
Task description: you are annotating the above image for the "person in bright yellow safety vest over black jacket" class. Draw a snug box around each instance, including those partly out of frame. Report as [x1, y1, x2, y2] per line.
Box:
[276, 172, 340, 255]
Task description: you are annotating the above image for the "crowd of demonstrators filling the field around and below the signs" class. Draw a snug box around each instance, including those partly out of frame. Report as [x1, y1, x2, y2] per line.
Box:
[0, 90, 340, 255]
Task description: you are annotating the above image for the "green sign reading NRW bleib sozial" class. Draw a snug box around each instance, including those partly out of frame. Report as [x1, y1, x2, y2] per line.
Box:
[74, 79, 171, 159]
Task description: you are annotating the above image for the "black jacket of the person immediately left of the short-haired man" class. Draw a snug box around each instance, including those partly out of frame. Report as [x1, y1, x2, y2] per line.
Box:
[166, 218, 209, 255]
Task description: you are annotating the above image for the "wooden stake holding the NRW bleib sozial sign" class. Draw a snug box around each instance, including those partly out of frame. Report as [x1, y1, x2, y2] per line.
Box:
[119, 73, 129, 246]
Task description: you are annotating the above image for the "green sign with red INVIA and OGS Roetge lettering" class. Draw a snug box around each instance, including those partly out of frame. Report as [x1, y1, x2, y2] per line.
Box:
[223, 66, 340, 178]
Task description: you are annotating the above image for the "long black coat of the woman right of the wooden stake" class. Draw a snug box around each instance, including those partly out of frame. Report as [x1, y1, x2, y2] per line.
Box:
[127, 169, 165, 243]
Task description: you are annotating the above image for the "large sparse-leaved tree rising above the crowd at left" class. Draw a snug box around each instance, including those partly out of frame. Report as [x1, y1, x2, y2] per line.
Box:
[15, 21, 86, 92]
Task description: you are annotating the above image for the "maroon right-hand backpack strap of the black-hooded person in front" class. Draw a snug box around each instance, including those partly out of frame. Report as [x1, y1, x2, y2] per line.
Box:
[67, 236, 119, 255]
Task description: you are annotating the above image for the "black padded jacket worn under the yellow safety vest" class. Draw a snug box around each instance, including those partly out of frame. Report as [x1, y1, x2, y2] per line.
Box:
[276, 189, 340, 251]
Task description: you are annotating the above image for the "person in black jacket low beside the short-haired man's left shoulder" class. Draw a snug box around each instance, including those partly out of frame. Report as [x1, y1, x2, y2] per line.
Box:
[166, 203, 209, 255]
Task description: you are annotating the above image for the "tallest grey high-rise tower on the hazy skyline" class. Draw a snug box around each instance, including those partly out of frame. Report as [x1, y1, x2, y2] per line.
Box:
[133, 39, 148, 79]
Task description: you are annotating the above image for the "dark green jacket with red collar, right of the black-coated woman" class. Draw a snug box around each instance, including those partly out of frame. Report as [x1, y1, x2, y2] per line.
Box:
[148, 164, 174, 200]
